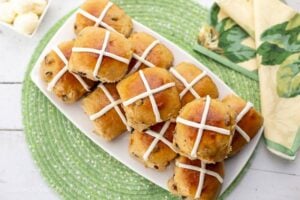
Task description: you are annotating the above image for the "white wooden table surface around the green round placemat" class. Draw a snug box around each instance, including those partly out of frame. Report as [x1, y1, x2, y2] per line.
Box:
[0, 0, 300, 200]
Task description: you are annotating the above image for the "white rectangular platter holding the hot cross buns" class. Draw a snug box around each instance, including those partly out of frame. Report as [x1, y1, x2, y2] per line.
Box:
[31, 8, 262, 193]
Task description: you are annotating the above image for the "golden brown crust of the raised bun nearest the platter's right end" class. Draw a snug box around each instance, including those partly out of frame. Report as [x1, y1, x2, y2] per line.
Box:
[173, 98, 235, 163]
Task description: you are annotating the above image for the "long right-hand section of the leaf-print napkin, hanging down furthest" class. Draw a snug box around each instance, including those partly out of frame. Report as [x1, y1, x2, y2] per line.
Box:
[253, 0, 300, 160]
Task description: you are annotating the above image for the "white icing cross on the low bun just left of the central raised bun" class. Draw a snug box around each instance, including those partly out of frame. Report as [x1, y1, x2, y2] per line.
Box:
[90, 83, 131, 131]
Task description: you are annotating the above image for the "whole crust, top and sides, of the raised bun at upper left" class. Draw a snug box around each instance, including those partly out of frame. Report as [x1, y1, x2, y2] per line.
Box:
[69, 27, 132, 83]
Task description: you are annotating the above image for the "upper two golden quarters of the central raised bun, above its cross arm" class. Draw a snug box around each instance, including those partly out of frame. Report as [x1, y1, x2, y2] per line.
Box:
[117, 67, 178, 101]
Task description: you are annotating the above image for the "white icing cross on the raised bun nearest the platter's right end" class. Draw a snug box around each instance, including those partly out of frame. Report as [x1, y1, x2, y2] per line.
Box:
[176, 96, 230, 158]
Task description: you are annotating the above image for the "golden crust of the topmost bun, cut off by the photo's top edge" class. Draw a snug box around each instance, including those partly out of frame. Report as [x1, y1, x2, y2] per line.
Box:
[75, 0, 133, 37]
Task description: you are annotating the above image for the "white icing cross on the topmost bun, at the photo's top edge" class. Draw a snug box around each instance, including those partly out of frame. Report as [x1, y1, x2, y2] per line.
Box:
[78, 1, 117, 32]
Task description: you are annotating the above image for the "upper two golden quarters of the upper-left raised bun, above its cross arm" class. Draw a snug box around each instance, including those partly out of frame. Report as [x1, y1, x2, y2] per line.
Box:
[74, 27, 132, 59]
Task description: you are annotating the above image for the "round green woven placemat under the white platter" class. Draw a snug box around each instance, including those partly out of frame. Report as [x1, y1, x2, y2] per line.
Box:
[22, 0, 259, 200]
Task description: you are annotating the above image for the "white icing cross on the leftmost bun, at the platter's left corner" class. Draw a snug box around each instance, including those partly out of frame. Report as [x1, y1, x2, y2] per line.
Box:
[47, 47, 90, 92]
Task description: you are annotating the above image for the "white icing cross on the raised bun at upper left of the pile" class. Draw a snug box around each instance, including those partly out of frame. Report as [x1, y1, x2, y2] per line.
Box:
[72, 30, 130, 80]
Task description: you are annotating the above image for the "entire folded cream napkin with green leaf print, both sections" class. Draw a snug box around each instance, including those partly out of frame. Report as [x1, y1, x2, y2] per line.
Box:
[196, 0, 300, 160]
